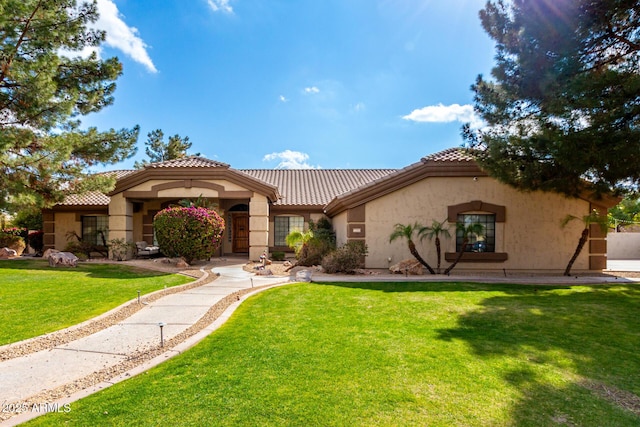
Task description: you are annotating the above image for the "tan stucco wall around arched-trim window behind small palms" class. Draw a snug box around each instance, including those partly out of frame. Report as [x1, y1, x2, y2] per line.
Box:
[362, 177, 589, 271]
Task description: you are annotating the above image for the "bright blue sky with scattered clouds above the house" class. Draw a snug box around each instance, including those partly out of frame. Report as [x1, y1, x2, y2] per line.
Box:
[83, 0, 494, 169]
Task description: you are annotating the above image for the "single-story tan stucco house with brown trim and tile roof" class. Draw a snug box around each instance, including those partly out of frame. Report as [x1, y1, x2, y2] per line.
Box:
[44, 148, 618, 272]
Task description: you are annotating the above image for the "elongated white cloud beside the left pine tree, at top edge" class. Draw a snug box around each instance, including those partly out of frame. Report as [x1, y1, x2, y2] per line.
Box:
[94, 0, 158, 73]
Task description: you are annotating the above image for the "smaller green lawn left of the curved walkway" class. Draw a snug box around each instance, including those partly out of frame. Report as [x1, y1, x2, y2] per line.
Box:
[0, 260, 193, 345]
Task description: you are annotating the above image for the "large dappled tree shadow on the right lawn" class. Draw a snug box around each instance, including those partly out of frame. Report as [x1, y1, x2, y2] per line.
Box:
[438, 285, 640, 425]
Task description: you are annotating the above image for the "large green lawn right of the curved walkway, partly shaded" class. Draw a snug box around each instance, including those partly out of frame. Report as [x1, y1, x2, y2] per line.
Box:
[27, 283, 640, 426]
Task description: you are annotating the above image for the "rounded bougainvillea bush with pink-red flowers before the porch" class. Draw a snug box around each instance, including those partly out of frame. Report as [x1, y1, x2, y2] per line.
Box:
[153, 206, 224, 263]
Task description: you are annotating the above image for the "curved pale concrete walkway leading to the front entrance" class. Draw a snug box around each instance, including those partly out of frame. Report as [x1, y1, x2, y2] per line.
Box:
[0, 265, 289, 426]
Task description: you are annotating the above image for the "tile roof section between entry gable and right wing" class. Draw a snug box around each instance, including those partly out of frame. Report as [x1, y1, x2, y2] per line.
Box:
[241, 169, 395, 206]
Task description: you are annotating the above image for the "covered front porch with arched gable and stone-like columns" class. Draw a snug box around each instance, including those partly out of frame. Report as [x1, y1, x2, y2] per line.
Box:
[109, 158, 279, 260]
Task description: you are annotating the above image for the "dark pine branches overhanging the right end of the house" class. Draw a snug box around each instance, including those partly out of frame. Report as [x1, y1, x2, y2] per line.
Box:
[463, 0, 640, 196]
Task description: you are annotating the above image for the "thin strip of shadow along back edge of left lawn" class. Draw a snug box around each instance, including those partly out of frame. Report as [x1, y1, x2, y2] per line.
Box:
[0, 258, 173, 279]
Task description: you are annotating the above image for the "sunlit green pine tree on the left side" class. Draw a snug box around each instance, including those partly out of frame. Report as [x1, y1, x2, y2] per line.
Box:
[0, 0, 138, 209]
